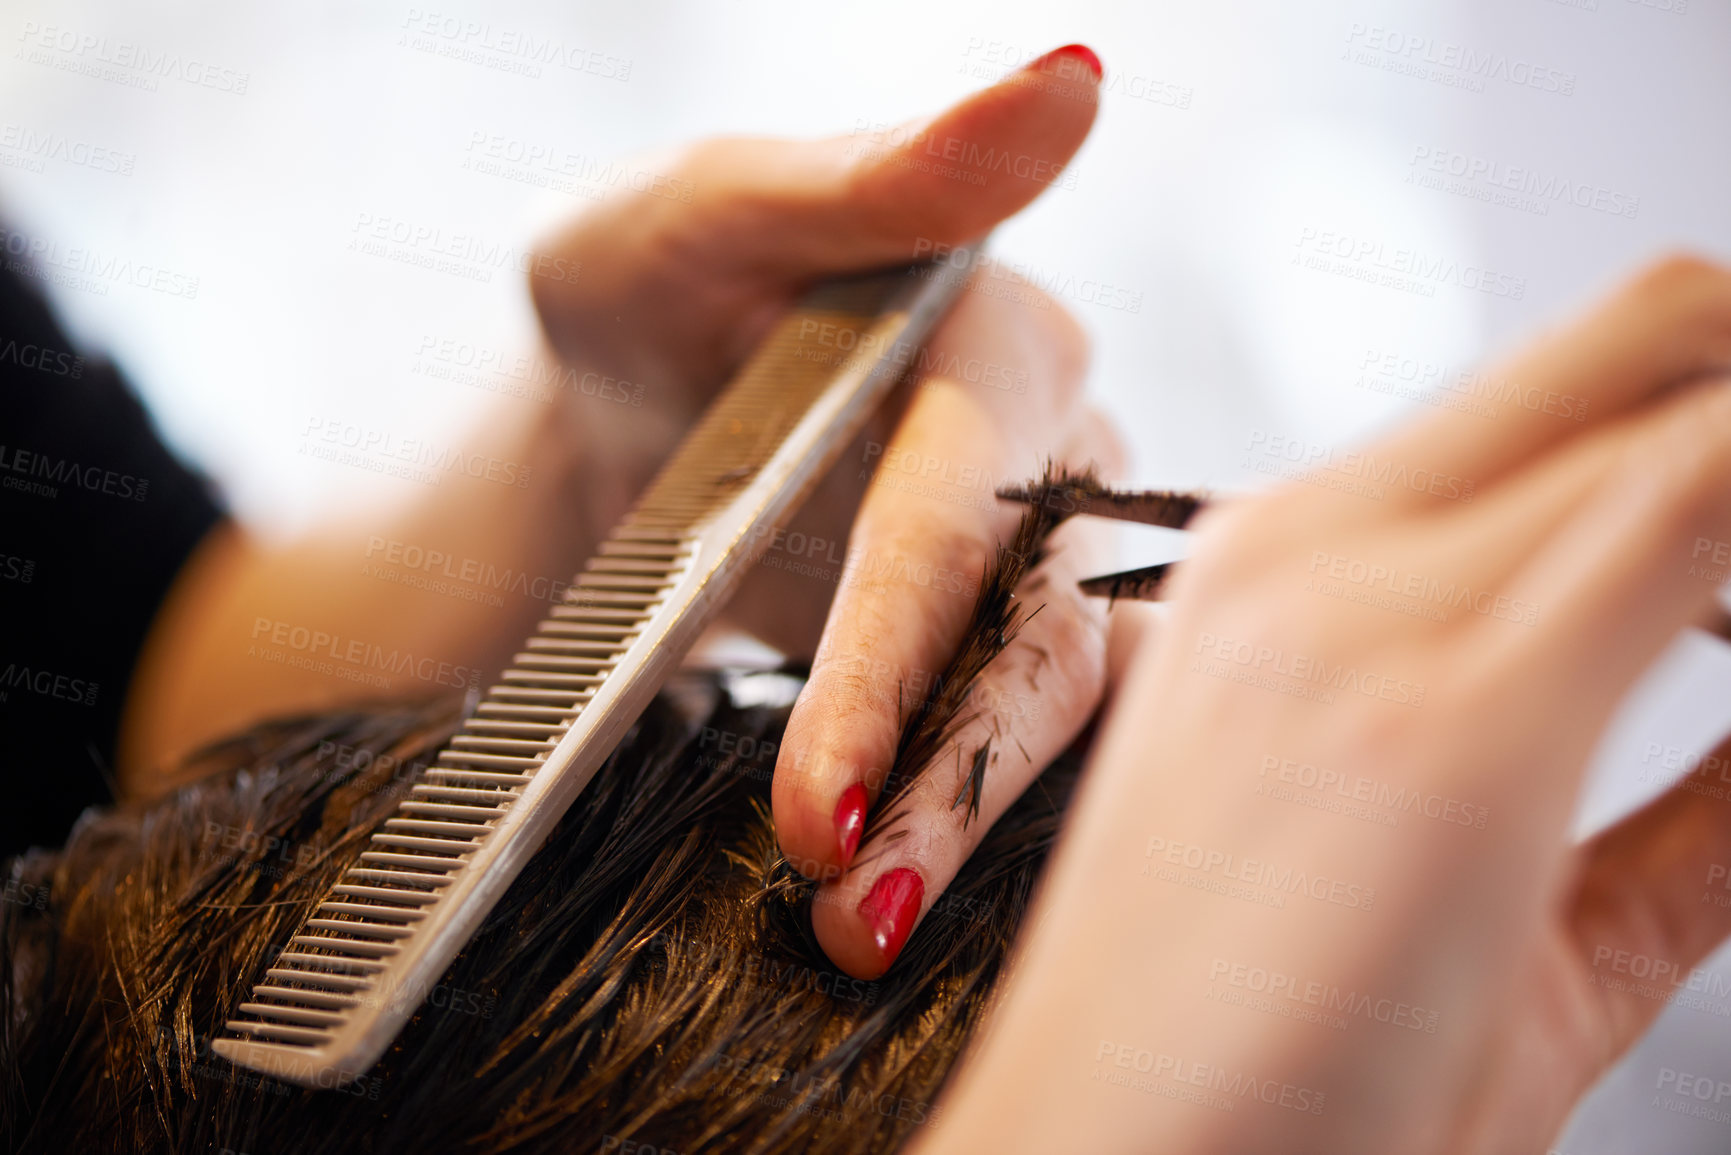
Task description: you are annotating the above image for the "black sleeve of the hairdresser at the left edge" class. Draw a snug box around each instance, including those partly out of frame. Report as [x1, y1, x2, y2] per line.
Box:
[0, 253, 222, 857]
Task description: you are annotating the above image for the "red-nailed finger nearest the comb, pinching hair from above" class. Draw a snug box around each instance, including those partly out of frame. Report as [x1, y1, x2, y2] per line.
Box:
[772, 280, 1085, 878]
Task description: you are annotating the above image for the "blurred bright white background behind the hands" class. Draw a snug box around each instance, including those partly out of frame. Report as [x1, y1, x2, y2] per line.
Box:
[0, 0, 1731, 1155]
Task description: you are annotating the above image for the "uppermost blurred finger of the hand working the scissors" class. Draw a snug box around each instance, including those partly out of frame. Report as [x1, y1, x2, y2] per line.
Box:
[1352, 258, 1731, 506]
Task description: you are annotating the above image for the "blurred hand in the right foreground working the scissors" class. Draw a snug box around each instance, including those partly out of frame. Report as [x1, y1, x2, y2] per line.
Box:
[923, 260, 1731, 1153]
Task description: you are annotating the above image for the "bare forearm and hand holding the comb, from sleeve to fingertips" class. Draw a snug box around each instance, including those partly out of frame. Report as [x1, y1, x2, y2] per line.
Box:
[119, 48, 1122, 978]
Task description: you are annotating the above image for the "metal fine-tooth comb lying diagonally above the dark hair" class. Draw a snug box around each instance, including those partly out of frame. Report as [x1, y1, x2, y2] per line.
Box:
[213, 251, 962, 1087]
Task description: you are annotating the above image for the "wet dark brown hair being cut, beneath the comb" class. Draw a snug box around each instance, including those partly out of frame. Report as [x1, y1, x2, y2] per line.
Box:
[0, 471, 1100, 1155]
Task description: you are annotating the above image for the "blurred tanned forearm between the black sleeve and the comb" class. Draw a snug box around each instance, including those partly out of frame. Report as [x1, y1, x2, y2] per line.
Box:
[118, 387, 606, 793]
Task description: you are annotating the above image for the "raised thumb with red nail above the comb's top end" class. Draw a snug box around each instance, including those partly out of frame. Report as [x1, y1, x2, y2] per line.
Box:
[695, 45, 1103, 279]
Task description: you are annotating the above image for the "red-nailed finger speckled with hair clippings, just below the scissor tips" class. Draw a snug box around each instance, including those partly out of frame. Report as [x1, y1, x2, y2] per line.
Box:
[812, 431, 1113, 978]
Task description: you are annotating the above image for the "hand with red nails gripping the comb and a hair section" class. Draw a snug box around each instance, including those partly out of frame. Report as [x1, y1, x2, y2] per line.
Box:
[531, 40, 1120, 977]
